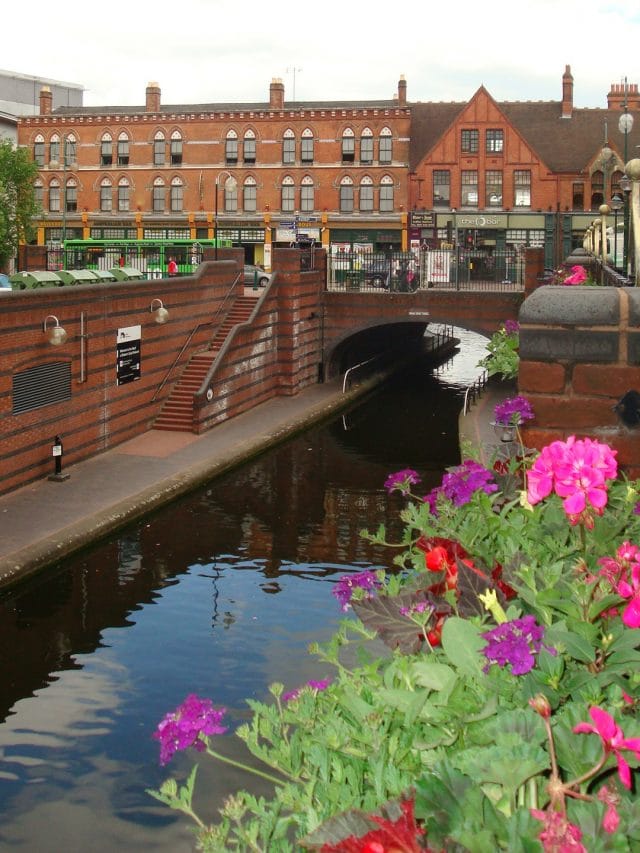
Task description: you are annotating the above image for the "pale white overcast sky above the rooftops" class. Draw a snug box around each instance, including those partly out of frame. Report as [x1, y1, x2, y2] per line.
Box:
[5, 0, 640, 107]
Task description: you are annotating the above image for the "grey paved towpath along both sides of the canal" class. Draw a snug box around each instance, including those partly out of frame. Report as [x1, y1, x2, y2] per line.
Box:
[0, 382, 510, 587]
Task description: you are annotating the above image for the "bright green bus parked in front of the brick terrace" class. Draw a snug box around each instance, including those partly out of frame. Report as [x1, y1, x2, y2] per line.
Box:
[57, 239, 231, 278]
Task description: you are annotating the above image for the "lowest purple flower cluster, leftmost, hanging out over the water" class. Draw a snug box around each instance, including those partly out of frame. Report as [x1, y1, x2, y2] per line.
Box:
[153, 693, 227, 765]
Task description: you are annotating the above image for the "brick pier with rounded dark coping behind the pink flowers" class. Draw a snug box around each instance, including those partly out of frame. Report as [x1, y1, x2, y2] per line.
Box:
[518, 286, 640, 477]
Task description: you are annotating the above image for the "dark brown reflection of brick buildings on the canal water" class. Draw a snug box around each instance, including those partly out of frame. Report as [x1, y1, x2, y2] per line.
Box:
[0, 356, 464, 719]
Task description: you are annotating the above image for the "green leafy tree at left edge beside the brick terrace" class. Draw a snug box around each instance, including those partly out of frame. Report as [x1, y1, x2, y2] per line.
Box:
[0, 140, 39, 269]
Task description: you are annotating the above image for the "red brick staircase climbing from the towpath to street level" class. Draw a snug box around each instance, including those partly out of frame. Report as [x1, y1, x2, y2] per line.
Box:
[153, 296, 257, 432]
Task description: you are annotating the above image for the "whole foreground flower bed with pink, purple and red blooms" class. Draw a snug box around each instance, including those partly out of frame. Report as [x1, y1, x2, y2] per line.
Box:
[150, 398, 640, 853]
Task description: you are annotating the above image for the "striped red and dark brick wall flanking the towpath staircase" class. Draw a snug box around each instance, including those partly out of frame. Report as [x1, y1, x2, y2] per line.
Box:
[0, 250, 325, 493]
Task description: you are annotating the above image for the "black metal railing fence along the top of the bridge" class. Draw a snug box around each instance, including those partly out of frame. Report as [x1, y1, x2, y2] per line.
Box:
[327, 247, 524, 293]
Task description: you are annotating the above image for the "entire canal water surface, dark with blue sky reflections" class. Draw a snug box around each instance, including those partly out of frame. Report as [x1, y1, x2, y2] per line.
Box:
[0, 332, 485, 853]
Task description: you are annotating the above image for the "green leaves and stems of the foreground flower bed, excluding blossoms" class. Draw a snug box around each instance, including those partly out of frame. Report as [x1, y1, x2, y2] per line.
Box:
[148, 456, 640, 853]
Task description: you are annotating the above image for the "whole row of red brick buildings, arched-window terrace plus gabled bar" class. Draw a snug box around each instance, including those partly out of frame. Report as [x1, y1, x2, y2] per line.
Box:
[18, 66, 640, 267]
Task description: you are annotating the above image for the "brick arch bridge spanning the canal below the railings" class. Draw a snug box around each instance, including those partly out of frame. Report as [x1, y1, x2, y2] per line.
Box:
[322, 290, 525, 379]
